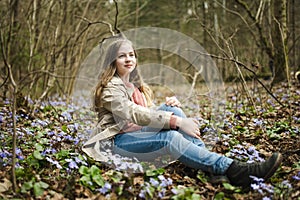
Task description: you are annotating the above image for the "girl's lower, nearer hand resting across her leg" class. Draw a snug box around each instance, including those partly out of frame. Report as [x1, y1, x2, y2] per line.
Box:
[176, 117, 201, 139]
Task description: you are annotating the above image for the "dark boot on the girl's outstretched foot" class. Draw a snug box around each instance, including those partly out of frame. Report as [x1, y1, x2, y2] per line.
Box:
[226, 153, 282, 189]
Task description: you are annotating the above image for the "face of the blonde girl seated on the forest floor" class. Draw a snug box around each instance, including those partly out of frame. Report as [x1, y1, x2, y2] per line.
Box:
[116, 42, 136, 77]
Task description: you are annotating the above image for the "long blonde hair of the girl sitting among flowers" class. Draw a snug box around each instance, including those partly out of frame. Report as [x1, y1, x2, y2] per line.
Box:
[94, 39, 152, 112]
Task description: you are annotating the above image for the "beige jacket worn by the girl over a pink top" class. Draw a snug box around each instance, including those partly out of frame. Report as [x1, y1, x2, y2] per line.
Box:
[82, 76, 172, 162]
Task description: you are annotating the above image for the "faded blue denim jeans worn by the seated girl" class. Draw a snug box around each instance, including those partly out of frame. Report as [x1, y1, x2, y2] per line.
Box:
[114, 104, 233, 174]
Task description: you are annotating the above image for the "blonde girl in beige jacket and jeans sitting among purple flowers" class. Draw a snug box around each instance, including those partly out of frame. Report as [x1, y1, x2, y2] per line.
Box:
[83, 38, 282, 188]
